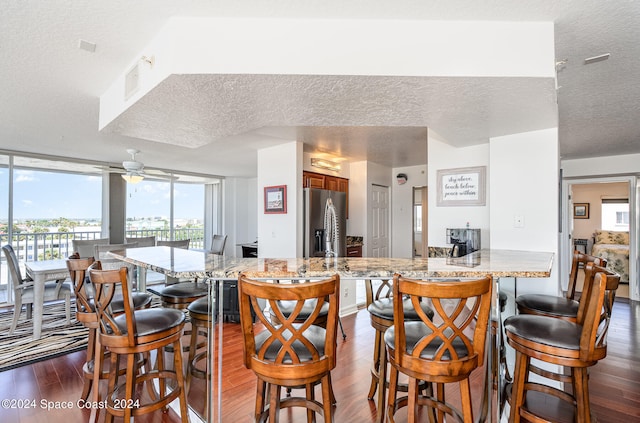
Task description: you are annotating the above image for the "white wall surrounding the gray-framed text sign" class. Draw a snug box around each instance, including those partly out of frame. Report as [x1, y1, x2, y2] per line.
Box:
[428, 131, 492, 248]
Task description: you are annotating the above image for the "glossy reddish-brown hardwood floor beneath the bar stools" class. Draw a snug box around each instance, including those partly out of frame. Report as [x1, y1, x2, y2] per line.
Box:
[0, 302, 640, 423]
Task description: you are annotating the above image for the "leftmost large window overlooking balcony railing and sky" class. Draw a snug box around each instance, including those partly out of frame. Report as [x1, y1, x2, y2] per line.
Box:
[0, 155, 102, 303]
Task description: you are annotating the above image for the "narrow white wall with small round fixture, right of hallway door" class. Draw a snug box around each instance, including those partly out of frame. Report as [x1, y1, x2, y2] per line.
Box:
[391, 166, 427, 258]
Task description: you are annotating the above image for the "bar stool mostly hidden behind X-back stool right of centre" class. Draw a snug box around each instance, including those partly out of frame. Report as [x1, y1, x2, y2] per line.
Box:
[365, 279, 433, 423]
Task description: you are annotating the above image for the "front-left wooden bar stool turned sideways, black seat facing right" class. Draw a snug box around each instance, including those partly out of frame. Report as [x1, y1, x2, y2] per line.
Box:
[88, 261, 189, 422]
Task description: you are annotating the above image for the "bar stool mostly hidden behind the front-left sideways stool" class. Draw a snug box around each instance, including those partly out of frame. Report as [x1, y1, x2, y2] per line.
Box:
[67, 253, 151, 400]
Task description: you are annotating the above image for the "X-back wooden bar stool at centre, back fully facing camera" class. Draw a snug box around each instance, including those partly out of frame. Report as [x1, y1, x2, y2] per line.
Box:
[238, 275, 340, 422]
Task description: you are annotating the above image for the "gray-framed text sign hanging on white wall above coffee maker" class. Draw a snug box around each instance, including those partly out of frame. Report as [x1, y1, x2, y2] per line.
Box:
[436, 166, 487, 206]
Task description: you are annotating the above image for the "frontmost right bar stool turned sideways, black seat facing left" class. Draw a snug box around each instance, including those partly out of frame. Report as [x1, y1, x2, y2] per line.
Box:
[505, 263, 620, 423]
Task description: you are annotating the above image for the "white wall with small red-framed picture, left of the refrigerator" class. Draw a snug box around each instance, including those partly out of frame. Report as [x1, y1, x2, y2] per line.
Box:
[257, 142, 302, 258]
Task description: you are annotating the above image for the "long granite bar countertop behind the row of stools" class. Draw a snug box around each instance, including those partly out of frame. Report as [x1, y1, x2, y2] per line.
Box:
[109, 247, 554, 279]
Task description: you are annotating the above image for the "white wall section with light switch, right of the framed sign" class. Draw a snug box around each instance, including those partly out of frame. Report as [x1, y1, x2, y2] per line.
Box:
[489, 128, 560, 295]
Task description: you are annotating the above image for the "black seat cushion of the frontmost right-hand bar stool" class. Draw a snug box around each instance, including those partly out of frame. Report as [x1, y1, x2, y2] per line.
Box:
[504, 314, 582, 350]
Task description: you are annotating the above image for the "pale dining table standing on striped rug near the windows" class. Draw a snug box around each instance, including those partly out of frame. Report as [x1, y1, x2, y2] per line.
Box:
[24, 259, 69, 339]
